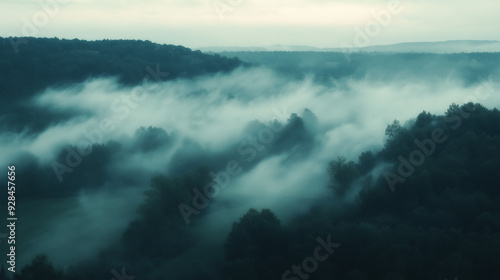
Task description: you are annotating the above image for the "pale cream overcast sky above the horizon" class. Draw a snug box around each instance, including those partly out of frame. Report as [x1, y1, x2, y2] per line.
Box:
[0, 0, 500, 48]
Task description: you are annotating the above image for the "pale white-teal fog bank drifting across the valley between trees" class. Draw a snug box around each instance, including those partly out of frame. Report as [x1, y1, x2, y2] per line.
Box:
[0, 60, 500, 269]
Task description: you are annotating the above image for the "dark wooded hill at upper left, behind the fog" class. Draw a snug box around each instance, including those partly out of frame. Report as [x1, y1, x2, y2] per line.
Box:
[0, 37, 248, 132]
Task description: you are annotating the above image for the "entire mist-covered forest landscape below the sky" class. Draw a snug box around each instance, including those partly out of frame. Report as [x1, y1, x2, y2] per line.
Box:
[0, 38, 500, 280]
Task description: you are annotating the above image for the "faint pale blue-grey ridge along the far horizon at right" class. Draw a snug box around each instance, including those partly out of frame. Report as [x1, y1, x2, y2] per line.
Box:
[198, 40, 500, 53]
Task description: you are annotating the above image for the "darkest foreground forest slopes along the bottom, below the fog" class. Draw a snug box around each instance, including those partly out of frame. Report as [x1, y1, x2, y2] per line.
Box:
[10, 103, 500, 280]
